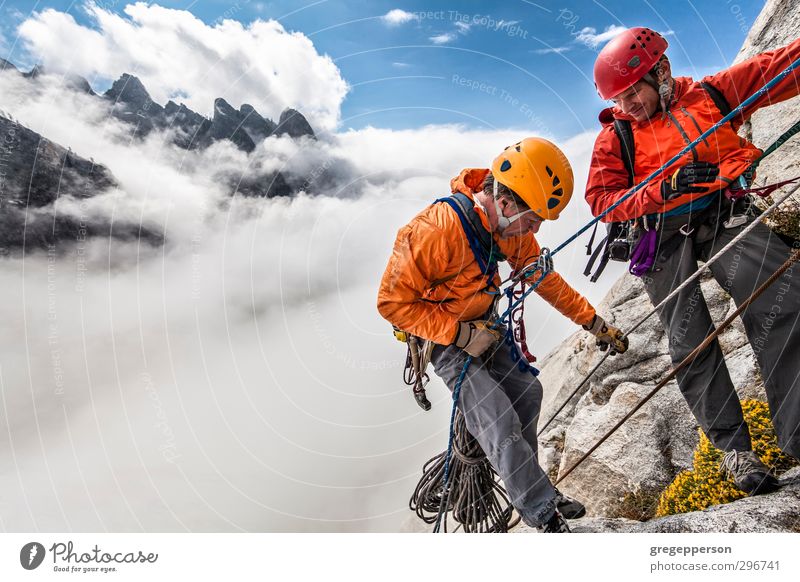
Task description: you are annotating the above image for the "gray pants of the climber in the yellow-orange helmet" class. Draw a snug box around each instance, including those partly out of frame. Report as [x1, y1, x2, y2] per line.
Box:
[431, 343, 556, 527]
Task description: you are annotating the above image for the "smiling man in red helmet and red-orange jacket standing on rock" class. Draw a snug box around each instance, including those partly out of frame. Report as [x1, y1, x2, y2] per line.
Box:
[586, 27, 800, 495]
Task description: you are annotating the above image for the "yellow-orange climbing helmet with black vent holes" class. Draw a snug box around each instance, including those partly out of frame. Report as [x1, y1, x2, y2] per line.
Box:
[492, 137, 575, 220]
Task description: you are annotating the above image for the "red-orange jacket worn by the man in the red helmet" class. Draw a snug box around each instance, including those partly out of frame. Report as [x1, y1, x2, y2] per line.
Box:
[586, 39, 800, 222]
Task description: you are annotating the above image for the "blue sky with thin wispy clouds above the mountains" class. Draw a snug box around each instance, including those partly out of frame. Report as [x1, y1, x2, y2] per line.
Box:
[0, 0, 762, 138]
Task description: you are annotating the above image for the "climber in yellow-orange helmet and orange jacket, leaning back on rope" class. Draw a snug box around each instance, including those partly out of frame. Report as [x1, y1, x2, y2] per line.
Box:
[378, 138, 628, 532]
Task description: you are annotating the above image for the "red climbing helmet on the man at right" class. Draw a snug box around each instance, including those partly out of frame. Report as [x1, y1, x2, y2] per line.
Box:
[594, 26, 669, 99]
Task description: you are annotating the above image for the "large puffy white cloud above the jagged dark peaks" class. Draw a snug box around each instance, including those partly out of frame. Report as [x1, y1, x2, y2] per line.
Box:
[19, 2, 347, 130]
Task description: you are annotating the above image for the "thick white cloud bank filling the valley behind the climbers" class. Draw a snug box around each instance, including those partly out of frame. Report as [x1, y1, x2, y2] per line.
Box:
[0, 67, 624, 531]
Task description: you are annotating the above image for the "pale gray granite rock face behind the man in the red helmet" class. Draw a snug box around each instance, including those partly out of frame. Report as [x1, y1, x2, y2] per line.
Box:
[540, 0, 800, 531]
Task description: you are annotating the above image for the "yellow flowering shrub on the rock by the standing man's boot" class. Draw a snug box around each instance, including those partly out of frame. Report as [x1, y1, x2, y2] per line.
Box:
[656, 400, 797, 517]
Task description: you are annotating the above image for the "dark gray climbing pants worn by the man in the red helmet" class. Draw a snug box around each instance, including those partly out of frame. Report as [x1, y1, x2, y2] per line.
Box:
[642, 197, 800, 457]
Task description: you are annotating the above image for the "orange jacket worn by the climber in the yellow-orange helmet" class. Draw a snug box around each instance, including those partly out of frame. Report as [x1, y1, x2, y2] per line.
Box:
[378, 169, 595, 345]
